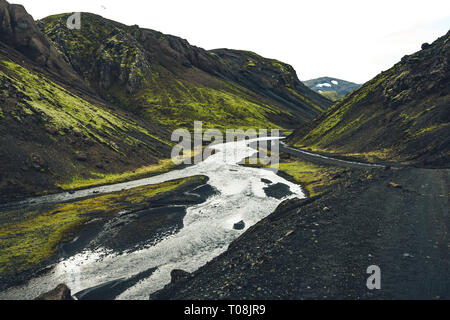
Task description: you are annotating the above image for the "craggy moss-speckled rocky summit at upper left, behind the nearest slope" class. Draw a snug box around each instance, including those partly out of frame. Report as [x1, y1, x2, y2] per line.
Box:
[38, 13, 149, 89]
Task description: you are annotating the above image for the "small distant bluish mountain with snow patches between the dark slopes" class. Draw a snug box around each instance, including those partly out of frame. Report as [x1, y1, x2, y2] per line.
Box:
[303, 77, 361, 101]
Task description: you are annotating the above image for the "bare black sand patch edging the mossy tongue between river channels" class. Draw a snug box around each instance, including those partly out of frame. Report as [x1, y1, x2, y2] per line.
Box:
[60, 183, 216, 257]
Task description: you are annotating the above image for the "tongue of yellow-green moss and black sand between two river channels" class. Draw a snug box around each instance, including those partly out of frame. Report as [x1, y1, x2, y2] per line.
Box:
[0, 176, 215, 290]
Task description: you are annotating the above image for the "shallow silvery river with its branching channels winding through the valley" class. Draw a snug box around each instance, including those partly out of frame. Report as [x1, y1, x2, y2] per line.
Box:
[0, 138, 305, 299]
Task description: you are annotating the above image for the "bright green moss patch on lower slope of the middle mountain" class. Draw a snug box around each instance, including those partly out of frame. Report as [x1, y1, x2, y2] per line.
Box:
[120, 75, 289, 129]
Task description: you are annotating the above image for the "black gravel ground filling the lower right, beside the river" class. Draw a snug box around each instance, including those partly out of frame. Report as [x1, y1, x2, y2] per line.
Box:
[150, 167, 450, 300]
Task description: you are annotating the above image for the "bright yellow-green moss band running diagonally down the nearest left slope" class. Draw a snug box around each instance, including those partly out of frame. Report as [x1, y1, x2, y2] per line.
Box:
[0, 60, 168, 151]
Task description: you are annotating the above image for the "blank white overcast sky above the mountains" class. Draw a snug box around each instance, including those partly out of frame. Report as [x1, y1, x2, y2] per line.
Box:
[9, 0, 450, 83]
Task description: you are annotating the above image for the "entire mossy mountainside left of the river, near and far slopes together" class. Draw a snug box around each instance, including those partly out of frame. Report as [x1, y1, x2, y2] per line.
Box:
[0, 0, 330, 202]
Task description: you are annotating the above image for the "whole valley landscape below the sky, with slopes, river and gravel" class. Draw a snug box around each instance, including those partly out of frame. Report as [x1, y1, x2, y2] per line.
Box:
[0, 0, 450, 300]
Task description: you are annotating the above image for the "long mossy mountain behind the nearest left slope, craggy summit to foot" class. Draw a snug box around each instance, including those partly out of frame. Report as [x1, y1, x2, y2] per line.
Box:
[38, 13, 330, 128]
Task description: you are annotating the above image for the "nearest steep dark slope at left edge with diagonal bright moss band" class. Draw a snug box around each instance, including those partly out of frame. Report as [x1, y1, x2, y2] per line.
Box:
[0, 0, 171, 202]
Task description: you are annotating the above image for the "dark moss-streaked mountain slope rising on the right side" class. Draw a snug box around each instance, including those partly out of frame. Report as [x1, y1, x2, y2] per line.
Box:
[288, 32, 450, 167]
